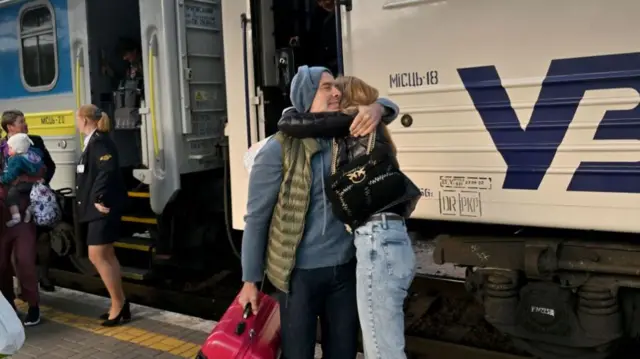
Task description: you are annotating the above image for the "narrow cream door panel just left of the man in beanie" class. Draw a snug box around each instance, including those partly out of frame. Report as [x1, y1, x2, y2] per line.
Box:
[222, 0, 260, 229]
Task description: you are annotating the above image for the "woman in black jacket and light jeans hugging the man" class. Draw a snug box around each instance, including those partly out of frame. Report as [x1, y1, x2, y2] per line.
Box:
[278, 77, 420, 359]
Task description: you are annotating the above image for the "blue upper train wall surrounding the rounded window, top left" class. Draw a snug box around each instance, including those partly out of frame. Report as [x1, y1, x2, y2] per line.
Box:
[0, 0, 73, 99]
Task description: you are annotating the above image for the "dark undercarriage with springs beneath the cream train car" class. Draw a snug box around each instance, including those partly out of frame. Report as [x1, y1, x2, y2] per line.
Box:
[434, 235, 640, 359]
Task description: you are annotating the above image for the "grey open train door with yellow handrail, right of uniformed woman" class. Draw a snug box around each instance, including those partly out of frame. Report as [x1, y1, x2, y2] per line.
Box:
[136, 0, 183, 214]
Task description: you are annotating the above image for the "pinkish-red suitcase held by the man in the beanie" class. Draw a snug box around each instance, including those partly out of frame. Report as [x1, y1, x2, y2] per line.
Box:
[197, 293, 280, 359]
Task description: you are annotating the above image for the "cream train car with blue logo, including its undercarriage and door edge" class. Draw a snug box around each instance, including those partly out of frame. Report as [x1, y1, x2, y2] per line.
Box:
[223, 0, 640, 358]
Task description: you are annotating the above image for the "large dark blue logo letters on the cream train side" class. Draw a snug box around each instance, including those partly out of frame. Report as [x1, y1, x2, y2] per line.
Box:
[456, 53, 640, 193]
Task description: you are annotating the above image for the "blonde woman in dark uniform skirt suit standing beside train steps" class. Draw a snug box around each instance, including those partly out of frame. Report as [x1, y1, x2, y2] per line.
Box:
[76, 105, 131, 326]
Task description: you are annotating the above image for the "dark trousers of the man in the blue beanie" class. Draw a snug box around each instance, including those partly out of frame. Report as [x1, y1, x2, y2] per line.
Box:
[278, 260, 360, 359]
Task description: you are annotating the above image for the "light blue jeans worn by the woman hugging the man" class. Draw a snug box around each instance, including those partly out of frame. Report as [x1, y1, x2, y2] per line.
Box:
[355, 214, 416, 359]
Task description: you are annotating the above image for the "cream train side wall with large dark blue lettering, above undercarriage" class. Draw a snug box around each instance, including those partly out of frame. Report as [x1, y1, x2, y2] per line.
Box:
[343, 0, 640, 232]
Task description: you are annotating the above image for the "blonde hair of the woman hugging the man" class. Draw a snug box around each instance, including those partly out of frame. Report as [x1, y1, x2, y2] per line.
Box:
[336, 76, 397, 156]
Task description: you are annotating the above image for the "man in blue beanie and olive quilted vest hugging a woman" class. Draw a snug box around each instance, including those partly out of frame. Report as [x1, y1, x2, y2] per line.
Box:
[239, 66, 398, 359]
